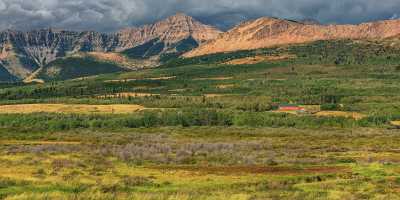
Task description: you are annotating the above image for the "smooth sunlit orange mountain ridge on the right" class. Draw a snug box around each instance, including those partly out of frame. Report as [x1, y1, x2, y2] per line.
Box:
[184, 18, 400, 57]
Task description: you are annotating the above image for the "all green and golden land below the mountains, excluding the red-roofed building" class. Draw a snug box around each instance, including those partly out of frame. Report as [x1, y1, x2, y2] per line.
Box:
[0, 40, 400, 200]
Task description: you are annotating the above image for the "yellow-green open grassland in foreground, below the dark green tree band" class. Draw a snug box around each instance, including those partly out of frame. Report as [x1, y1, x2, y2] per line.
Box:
[0, 127, 400, 200]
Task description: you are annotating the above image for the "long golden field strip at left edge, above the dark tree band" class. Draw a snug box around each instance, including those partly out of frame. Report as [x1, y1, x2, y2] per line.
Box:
[0, 104, 145, 114]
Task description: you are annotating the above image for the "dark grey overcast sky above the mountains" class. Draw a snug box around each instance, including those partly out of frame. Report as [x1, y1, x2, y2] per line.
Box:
[0, 0, 400, 32]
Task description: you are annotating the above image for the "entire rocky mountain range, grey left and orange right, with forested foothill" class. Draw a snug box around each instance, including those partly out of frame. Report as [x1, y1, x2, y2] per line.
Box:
[0, 13, 400, 82]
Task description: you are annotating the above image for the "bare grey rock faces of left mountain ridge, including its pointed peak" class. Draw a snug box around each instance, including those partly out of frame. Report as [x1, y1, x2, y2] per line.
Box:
[0, 14, 221, 79]
